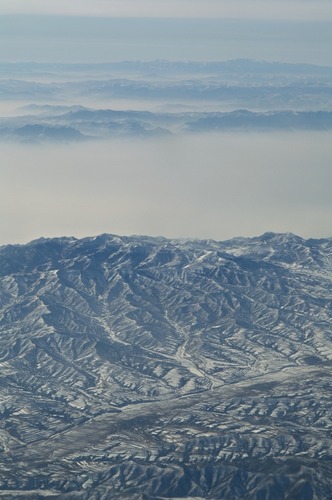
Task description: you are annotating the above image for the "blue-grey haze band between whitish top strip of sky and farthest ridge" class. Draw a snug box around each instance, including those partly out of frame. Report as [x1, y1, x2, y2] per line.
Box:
[0, 16, 332, 65]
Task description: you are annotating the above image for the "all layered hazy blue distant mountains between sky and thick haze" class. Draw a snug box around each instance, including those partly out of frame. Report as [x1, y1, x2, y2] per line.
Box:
[0, 59, 332, 143]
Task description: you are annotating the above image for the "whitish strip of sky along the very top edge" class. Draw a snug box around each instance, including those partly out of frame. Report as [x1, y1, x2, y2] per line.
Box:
[0, 0, 332, 21]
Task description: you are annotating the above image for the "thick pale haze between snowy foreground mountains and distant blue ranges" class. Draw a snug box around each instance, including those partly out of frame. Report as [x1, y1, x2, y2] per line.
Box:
[0, 132, 332, 244]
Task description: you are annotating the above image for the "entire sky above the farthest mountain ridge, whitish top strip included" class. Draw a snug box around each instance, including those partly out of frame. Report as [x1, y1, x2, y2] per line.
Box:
[0, 0, 332, 65]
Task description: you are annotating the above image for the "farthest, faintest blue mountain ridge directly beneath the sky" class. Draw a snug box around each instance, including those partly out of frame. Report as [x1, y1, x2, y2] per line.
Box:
[0, 59, 332, 87]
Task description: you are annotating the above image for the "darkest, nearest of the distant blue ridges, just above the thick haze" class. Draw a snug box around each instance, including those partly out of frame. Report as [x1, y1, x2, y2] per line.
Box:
[0, 106, 332, 142]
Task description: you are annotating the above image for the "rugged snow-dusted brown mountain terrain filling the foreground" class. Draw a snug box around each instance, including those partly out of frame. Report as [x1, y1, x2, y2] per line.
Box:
[0, 233, 332, 500]
